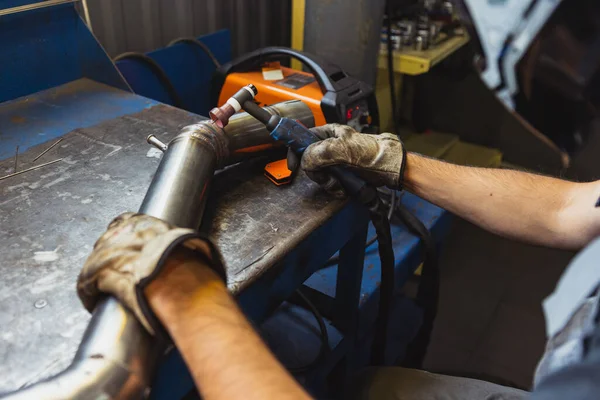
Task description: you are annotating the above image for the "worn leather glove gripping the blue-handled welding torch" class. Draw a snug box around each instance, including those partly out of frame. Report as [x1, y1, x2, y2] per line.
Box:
[302, 124, 406, 190]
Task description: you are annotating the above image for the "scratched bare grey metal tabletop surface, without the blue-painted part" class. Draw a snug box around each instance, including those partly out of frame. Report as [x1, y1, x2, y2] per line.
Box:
[0, 87, 344, 393]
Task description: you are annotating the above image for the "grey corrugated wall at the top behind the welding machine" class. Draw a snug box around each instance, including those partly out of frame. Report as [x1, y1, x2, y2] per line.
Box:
[87, 0, 291, 57]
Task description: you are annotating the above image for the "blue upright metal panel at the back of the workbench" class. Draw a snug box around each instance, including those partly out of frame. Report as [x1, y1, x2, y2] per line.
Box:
[0, 4, 129, 102]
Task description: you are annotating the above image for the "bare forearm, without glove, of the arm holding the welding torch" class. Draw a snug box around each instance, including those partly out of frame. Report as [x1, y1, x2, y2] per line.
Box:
[404, 153, 600, 249]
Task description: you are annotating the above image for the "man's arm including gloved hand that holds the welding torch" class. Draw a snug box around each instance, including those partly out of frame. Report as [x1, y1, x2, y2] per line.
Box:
[302, 124, 600, 249]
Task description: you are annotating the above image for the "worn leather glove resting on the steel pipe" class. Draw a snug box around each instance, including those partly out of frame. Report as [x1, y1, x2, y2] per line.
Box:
[77, 213, 226, 336]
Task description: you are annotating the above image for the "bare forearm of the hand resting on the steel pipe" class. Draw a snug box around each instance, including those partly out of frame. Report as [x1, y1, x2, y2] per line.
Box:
[145, 251, 310, 400]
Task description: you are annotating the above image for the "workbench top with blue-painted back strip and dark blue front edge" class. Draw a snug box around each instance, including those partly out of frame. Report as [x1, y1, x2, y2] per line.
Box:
[0, 79, 367, 391]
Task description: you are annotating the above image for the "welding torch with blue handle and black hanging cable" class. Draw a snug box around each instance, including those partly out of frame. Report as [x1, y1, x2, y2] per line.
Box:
[209, 84, 394, 364]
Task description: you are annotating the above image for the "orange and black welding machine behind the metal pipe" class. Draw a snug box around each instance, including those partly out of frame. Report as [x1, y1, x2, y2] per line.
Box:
[211, 47, 379, 186]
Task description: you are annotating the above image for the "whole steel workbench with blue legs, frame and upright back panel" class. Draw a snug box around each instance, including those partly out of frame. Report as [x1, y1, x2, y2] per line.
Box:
[0, 1, 447, 399]
